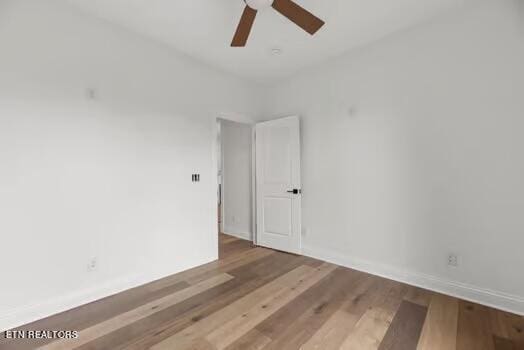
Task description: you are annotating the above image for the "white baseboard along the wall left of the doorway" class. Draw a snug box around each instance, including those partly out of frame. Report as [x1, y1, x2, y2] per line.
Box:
[0, 257, 217, 332]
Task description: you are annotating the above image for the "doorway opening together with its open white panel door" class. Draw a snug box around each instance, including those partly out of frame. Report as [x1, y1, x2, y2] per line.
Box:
[216, 117, 302, 254]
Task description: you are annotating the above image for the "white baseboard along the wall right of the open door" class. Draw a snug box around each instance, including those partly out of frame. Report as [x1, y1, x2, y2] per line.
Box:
[302, 243, 524, 316]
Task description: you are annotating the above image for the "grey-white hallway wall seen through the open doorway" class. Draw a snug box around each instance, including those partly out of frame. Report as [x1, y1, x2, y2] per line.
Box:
[221, 120, 252, 240]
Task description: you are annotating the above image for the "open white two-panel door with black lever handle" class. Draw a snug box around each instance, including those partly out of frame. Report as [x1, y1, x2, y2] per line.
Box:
[255, 117, 302, 254]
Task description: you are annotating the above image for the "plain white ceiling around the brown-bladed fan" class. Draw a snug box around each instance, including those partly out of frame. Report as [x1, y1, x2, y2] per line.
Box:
[69, 0, 470, 82]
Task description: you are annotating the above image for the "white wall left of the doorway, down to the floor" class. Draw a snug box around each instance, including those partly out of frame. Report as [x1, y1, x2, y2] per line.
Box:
[0, 0, 259, 329]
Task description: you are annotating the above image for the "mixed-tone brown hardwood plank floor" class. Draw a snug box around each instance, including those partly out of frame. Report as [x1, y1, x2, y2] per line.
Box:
[0, 235, 524, 350]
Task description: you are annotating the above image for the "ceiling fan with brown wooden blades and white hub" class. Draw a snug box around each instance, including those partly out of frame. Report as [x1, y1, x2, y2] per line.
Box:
[231, 0, 324, 47]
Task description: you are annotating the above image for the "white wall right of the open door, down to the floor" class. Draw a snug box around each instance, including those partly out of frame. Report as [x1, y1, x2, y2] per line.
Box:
[267, 0, 524, 313]
